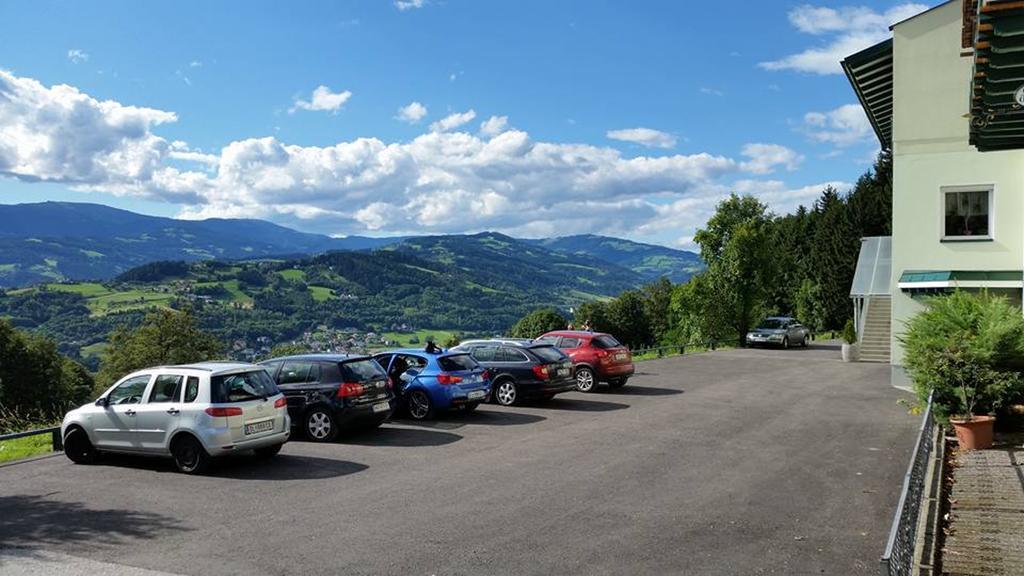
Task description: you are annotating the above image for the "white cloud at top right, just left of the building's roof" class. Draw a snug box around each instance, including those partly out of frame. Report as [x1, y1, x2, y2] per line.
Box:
[758, 3, 928, 74]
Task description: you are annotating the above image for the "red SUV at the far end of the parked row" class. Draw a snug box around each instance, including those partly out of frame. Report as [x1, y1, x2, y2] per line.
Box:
[537, 330, 635, 392]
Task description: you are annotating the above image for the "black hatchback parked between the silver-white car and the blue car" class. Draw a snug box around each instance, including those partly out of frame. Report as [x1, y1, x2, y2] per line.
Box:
[261, 354, 397, 442]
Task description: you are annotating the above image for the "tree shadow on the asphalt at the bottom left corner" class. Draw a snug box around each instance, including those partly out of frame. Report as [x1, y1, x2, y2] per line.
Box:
[0, 495, 188, 549]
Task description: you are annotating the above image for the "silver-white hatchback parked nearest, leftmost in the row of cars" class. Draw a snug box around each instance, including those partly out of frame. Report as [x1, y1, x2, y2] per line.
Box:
[60, 362, 292, 474]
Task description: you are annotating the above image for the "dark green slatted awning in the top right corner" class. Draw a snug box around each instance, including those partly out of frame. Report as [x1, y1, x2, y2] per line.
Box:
[971, 0, 1024, 152]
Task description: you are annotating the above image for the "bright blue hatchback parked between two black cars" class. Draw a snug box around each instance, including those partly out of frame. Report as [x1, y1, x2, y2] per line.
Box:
[374, 348, 490, 420]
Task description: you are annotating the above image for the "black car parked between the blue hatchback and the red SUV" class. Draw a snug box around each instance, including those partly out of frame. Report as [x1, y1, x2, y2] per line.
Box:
[453, 339, 575, 406]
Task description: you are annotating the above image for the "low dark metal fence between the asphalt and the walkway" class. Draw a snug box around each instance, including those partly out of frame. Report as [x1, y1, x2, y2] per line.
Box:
[882, 397, 935, 576]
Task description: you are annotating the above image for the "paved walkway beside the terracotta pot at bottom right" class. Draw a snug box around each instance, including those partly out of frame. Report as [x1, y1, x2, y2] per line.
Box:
[942, 442, 1024, 576]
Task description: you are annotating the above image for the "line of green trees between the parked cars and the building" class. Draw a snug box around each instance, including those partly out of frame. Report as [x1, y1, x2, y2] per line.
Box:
[510, 152, 892, 348]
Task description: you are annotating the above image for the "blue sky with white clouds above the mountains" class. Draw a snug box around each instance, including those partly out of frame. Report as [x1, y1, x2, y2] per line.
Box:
[0, 0, 927, 247]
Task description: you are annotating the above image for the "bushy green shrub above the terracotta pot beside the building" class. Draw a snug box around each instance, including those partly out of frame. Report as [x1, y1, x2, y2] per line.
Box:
[900, 291, 1024, 417]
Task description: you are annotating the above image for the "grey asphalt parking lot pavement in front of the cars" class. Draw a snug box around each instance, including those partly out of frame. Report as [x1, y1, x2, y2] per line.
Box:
[0, 346, 918, 575]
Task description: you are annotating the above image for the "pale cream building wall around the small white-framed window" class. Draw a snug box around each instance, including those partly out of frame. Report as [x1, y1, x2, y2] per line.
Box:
[892, 1, 1024, 365]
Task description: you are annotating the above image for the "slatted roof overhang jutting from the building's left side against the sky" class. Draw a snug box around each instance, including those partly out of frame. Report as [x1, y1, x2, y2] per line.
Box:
[842, 38, 893, 150]
